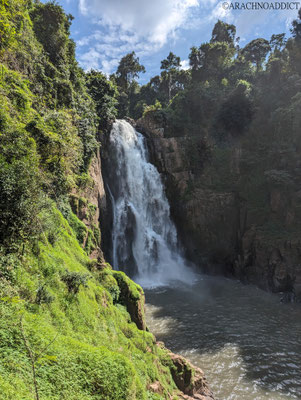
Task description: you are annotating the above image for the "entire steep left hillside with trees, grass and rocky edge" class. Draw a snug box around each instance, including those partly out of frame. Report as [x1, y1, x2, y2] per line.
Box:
[0, 0, 212, 400]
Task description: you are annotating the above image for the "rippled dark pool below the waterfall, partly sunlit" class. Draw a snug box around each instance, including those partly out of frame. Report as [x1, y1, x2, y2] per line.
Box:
[146, 277, 301, 400]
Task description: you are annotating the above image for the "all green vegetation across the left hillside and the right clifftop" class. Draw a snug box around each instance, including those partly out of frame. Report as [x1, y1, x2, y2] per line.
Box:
[0, 0, 301, 400]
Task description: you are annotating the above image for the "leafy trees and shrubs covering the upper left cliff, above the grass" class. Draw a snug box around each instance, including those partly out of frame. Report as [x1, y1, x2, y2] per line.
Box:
[0, 0, 116, 251]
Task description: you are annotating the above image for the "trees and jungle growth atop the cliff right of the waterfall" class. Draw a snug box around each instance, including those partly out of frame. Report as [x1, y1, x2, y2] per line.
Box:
[111, 10, 301, 148]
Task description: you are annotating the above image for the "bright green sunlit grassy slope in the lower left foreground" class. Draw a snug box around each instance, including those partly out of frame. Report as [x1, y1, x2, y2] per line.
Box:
[0, 207, 175, 400]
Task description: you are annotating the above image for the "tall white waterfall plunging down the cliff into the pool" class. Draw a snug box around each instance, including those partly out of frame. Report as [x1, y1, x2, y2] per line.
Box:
[109, 120, 193, 287]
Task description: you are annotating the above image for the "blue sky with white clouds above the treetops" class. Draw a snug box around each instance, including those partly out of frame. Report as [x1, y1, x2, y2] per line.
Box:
[58, 0, 301, 83]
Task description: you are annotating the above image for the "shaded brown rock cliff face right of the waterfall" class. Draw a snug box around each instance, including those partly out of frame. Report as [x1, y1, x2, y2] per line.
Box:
[137, 114, 301, 301]
